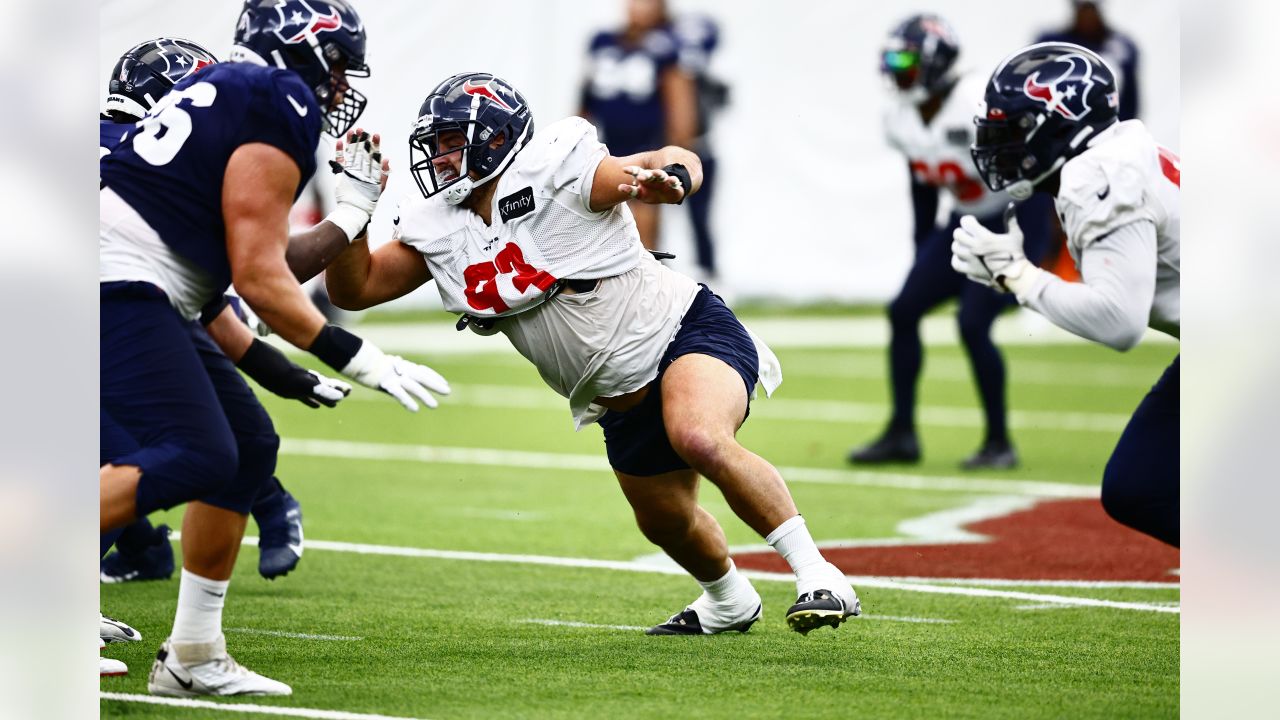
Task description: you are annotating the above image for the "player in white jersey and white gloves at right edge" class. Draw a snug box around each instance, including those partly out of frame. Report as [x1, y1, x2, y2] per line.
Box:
[952, 42, 1181, 547]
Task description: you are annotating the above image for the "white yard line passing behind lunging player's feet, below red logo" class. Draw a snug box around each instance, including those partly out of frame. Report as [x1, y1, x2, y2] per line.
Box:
[240, 533, 1179, 614]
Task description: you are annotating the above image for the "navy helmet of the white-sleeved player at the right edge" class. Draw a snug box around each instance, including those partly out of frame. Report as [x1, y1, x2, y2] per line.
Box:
[972, 42, 1120, 200]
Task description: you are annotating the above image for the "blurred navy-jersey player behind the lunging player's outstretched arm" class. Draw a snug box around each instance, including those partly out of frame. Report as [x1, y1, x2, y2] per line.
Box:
[579, 0, 698, 250]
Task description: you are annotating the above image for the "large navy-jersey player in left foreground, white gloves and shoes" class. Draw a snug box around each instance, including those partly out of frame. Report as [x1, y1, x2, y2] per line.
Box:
[99, 0, 448, 697]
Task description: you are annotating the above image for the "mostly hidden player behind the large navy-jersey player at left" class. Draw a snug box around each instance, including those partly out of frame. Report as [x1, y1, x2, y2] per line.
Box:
[100, 37, 335, 599]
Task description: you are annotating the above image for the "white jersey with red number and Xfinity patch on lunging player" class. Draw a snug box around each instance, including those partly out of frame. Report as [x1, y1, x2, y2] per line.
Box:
[396, 118, 781, 428]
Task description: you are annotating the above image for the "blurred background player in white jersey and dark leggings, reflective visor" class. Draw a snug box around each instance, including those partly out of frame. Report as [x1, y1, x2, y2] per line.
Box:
[849, 14, 1051, 470]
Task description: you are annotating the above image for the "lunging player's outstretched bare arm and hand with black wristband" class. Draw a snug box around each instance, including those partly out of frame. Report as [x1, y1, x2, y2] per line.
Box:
[591, 145, 703, 211]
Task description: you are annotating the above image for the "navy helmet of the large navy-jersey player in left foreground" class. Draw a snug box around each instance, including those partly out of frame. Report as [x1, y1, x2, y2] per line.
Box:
[230, 0, 369, 137]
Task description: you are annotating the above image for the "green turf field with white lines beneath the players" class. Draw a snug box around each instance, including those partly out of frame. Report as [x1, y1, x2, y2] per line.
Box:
[101, 312, 1179, 720]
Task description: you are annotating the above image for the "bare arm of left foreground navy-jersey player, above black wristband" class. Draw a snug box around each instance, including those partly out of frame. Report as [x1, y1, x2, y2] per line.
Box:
[223, 142, 325, 348]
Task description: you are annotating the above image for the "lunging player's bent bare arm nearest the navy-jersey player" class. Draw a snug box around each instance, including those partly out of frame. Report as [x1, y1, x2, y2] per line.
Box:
[325, 234, 431, 310]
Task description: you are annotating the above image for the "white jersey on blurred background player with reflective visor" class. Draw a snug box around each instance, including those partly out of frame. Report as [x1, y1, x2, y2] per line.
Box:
[884, 73, 1009, 218]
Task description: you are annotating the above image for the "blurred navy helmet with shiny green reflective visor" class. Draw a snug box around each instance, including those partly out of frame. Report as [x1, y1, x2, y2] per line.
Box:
[881, 14, 960, 104]
